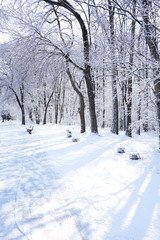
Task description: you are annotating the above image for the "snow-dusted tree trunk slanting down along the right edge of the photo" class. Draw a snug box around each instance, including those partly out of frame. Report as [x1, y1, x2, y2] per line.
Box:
[142, 0, 160, 151]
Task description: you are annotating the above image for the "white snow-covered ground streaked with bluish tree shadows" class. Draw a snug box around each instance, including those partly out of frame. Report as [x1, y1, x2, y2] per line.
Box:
[0, 122, 160, 240]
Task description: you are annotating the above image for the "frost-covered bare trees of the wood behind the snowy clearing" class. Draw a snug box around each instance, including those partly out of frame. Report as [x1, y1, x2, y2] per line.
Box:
[0, 0, 160, 148]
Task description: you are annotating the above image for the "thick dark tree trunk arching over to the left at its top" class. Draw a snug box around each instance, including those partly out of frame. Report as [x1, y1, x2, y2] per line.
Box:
[44, 0, 98, 133]
